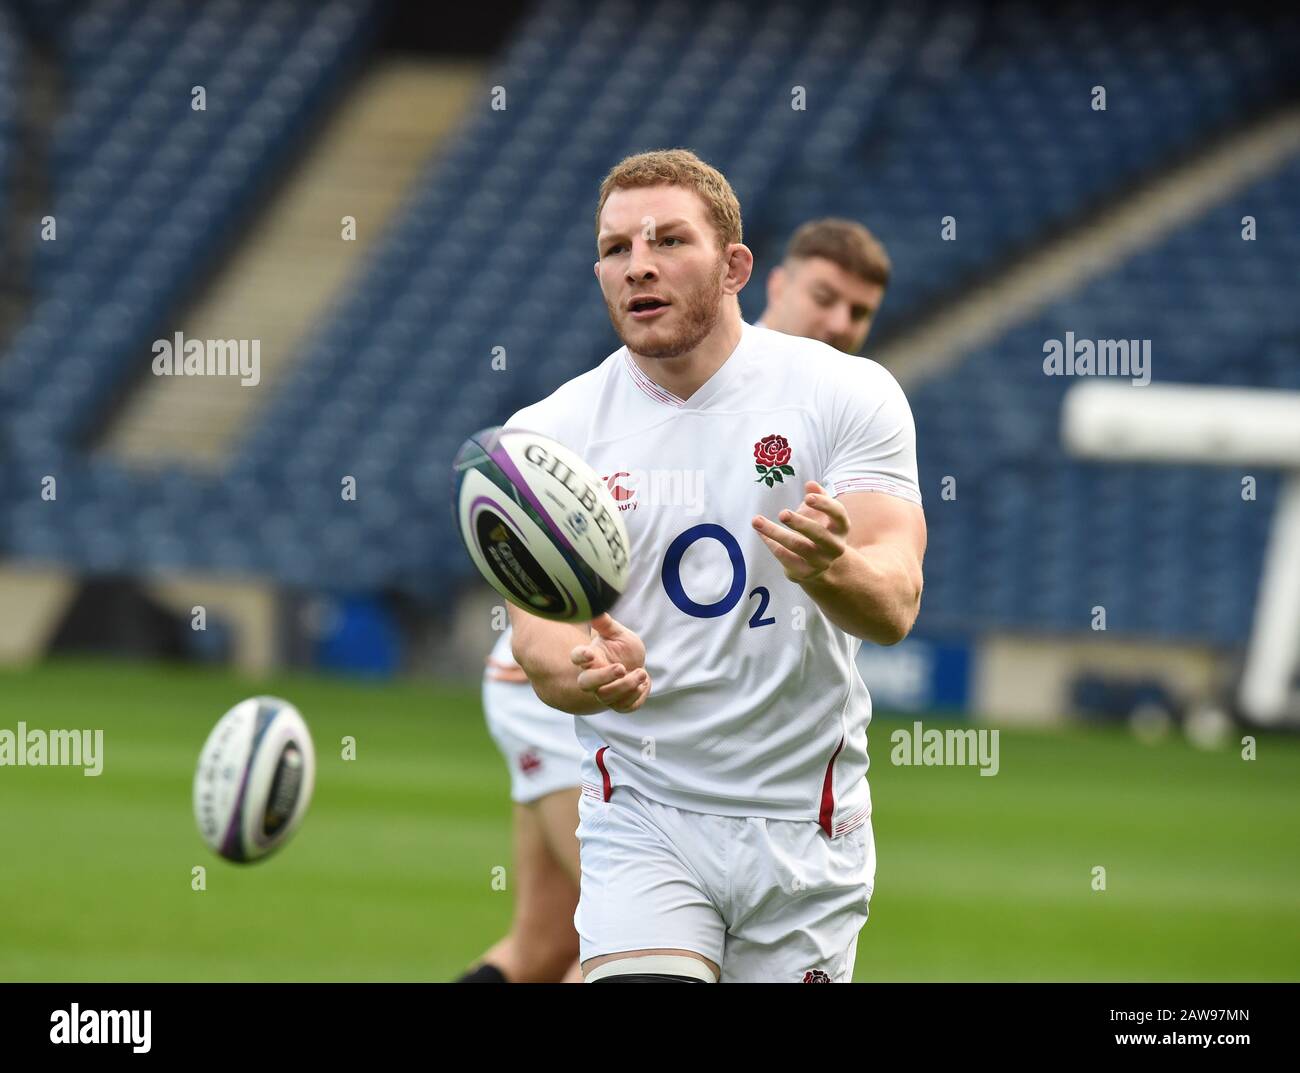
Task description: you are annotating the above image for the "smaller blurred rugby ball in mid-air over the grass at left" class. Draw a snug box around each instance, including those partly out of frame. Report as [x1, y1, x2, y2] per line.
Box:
[194, 697, 316, 862]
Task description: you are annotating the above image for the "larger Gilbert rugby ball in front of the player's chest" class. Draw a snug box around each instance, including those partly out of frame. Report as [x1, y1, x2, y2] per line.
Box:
[454, 428, 629, 622]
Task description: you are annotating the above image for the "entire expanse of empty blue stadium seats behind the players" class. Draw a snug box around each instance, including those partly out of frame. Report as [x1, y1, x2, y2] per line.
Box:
[0, 0, 1300, 652]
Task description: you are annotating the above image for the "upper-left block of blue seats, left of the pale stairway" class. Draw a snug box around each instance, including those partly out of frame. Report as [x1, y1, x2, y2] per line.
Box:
[0, 0, 374, 447]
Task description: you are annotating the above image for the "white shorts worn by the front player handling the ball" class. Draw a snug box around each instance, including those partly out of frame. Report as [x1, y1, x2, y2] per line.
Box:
[573, 786, 876, 983]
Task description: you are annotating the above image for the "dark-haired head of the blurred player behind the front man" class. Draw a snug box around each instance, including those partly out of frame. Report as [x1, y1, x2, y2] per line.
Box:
[758, 217, 892, 354]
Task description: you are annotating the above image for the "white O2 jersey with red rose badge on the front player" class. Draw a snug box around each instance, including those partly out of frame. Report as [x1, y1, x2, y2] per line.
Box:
[507, 324, 920, 836]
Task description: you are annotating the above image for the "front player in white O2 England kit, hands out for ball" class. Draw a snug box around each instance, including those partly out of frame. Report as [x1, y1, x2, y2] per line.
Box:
[507, 150, 926, 982]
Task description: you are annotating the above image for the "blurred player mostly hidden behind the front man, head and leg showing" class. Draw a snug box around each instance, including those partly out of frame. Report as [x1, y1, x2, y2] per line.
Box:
[462, 219, 891, 983]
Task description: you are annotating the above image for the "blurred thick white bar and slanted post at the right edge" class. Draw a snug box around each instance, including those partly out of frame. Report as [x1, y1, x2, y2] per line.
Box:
[1061, 382, 1300, 724]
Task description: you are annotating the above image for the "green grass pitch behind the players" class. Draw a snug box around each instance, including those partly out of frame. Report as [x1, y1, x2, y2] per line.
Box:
[0, 661, 1300, 981]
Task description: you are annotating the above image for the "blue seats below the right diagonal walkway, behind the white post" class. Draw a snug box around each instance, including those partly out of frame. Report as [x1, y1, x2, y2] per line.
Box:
[910, 157, 1300, 642]
